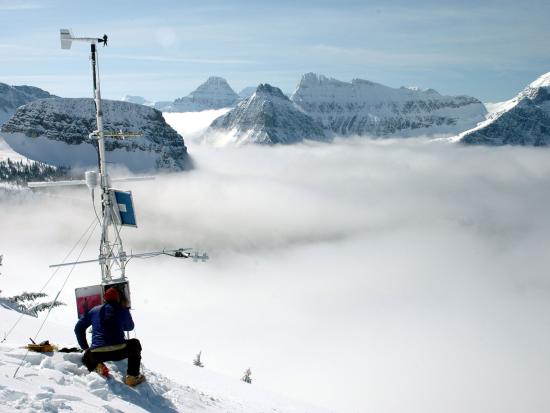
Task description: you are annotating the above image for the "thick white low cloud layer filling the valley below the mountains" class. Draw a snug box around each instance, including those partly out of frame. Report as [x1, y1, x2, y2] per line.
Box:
[0, 139, 550, 413]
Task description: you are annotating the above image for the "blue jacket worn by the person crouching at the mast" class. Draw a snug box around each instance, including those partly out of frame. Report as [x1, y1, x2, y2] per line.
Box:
[74, 302, 134, 350]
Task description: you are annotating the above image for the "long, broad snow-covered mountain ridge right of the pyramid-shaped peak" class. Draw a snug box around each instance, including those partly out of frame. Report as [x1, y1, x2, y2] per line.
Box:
[291, 73, 487, 137]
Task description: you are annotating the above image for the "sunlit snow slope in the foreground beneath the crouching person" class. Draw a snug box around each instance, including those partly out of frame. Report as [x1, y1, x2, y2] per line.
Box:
[0, 303, 325, 413]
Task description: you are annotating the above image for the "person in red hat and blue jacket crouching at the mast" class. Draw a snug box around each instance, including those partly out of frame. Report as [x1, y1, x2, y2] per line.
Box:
[74, 287, 145, 387]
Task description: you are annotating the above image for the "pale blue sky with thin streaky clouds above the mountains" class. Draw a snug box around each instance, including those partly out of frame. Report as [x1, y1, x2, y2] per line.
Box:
[0, 0, 550, 102]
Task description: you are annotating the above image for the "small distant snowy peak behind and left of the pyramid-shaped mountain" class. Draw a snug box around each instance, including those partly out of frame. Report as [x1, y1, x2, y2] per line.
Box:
[162, 76, 239, 112]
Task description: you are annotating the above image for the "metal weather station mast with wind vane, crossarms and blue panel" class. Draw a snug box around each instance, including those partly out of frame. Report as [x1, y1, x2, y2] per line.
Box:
[28, 29, 209, 317]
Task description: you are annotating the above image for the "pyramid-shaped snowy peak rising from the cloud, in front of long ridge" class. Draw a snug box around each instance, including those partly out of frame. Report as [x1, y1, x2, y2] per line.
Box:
[207, 84, 326, 145]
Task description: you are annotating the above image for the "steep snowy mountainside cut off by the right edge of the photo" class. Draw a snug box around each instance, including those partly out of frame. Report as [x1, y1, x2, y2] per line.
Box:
[456, 72, 550, 146]
